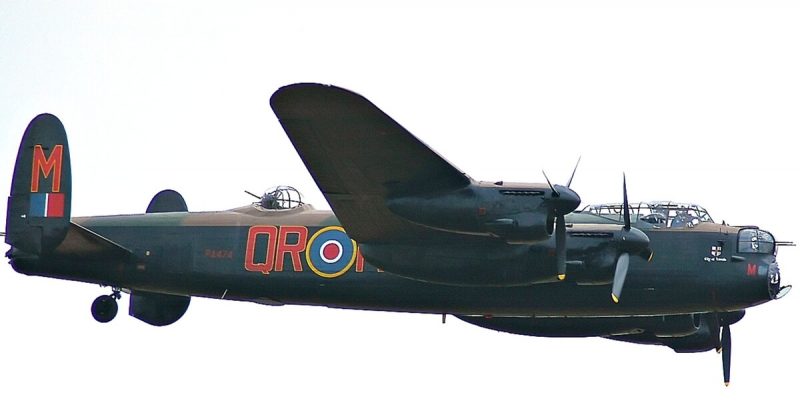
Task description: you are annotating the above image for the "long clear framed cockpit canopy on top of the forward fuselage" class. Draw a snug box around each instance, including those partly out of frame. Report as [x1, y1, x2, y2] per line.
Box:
[579, 201, 714, 228]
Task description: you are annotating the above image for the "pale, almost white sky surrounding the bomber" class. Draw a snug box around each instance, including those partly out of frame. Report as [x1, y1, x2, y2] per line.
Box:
[0, 1, 800, 418]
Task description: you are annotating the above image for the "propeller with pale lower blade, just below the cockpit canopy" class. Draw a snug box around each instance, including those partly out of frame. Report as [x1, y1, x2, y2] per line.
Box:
[611, 173, 653, 304]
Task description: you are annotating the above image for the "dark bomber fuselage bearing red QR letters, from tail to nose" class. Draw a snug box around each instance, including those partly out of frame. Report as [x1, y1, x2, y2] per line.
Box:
[11, 211, 775, 317]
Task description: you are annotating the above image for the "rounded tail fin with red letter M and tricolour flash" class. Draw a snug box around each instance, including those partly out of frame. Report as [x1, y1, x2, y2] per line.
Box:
[5, 114, 72, 255]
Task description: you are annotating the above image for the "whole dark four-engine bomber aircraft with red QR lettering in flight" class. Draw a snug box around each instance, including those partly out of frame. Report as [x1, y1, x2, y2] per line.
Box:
[5, 84, 790, 384]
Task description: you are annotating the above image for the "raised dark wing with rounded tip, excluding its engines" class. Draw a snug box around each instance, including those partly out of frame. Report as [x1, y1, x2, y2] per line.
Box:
[270, 84, 471, 242]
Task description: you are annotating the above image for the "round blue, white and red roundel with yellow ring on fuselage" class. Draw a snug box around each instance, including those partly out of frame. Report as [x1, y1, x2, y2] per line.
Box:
[306, 226, 356, 278]
